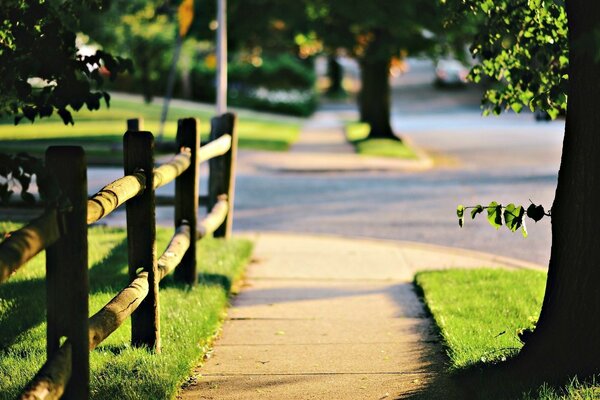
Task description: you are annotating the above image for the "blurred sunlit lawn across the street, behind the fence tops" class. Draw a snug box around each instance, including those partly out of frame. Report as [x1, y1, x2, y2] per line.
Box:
[0, 99, 300, 163]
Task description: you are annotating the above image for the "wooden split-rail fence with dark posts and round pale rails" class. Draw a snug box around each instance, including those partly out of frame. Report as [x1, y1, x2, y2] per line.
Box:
[0, 113, 237, 399]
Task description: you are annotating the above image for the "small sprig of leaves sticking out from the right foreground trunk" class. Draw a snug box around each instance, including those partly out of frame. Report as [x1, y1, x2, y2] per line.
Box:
[456, 201, 550, 237]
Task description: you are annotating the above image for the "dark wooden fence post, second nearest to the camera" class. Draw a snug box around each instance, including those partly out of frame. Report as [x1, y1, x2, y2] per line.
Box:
[123, 131, 160, 353]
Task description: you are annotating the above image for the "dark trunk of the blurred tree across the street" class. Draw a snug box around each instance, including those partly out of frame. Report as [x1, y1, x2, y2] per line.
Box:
[358, 56, 400, 140]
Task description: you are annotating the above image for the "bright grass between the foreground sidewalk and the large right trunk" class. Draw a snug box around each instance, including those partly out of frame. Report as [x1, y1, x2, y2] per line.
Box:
[415, 269, 600, 400]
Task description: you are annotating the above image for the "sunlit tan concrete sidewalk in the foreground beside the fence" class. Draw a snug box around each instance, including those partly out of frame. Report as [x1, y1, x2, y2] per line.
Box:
[181, 233, 535, 400]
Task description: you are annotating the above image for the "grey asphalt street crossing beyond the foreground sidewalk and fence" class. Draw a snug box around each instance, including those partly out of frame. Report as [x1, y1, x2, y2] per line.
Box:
[89, 63, 564, 265]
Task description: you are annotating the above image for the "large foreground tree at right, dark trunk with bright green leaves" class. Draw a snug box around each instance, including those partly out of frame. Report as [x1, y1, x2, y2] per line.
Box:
[449, 0, 600, 379]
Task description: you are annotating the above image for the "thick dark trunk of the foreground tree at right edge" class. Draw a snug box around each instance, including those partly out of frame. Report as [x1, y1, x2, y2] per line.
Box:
[519, 0, 600, 379]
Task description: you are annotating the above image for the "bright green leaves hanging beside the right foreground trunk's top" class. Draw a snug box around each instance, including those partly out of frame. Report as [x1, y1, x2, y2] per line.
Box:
[441, 0, 569, 118]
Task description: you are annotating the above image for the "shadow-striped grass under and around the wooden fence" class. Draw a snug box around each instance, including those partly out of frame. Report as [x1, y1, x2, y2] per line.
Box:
[0, 224, 252, 399]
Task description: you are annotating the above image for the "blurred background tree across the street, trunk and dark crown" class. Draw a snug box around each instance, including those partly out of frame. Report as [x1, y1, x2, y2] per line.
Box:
[306, 0, 440, 139]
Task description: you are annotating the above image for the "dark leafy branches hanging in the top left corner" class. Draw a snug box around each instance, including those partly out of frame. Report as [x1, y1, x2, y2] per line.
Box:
[0, 0, 132, 124]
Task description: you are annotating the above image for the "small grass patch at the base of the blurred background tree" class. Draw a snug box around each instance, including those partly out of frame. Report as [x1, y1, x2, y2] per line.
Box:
[346, 122, 417, 160]
